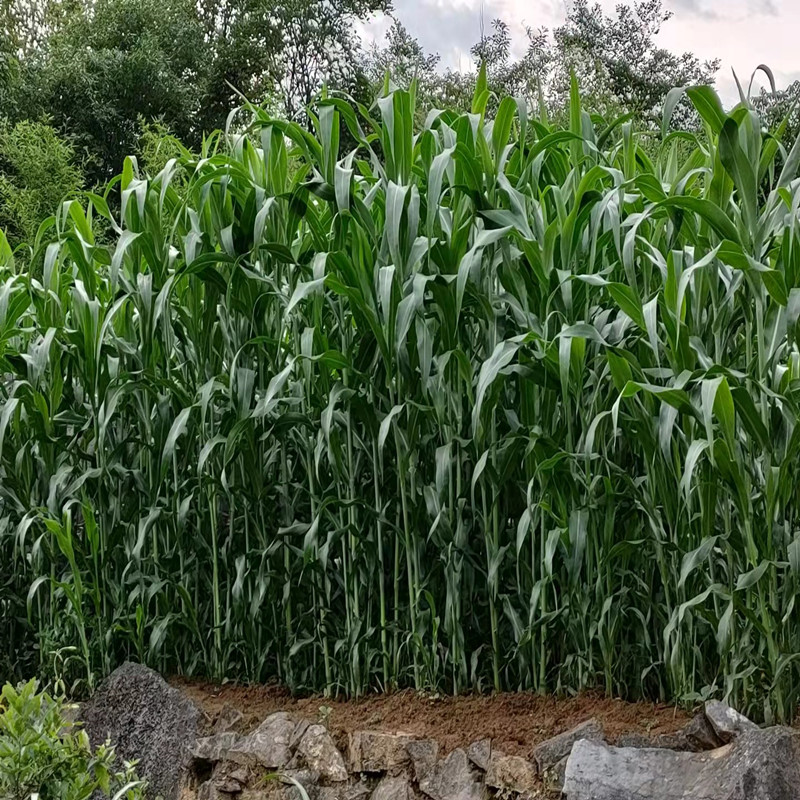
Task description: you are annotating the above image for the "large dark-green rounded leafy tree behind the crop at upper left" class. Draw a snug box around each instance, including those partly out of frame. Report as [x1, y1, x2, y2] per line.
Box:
[32, 0, 208, 180]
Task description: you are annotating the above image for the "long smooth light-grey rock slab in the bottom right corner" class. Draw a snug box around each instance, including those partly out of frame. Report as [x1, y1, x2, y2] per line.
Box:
[564, 727, 800, 800]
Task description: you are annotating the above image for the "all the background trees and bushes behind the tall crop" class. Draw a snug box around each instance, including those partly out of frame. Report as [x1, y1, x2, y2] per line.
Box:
[0, 0, 724, 246]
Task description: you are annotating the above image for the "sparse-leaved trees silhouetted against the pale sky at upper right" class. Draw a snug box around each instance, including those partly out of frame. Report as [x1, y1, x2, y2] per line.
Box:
[367, 0, 719, 124]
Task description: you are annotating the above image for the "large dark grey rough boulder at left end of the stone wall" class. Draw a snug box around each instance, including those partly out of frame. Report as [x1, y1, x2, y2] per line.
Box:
[80, 663, 201, 800]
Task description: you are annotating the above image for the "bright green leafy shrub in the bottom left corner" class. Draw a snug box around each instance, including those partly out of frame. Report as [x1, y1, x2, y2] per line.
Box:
[0, 681, 144, 800]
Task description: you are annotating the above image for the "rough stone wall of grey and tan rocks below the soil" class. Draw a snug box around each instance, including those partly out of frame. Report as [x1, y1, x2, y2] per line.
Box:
[78, 665, 800, 800]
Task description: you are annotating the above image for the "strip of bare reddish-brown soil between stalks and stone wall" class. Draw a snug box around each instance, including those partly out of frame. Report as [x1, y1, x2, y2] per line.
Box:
[172, 678, 688, 756]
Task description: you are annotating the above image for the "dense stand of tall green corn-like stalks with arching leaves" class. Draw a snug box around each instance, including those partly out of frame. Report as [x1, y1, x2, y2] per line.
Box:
[0, 73, 800, 718]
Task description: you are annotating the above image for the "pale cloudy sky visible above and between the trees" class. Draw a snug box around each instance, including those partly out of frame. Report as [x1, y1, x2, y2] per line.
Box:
[365, 0, 800, 103]
